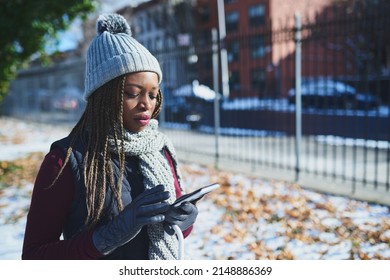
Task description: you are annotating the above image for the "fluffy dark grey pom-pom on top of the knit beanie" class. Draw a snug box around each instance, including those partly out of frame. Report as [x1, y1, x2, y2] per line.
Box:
[96, 14, 132, 36]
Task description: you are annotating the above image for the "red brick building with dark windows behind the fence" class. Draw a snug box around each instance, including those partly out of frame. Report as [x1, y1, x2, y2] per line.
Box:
[196, 0, 338, 98]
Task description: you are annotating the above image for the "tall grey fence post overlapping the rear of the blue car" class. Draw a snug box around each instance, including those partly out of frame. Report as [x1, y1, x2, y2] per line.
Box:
[295, 12, 302, 181]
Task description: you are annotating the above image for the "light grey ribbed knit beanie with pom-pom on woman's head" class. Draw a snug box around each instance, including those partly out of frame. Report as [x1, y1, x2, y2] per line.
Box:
[84, 14, 162, 100]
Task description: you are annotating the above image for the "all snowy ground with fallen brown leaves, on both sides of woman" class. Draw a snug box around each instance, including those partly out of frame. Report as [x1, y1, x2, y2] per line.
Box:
[0, 118, 390, 260]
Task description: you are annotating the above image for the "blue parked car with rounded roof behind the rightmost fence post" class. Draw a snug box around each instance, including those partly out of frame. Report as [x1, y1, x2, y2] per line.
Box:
[288, 79, 380, 110]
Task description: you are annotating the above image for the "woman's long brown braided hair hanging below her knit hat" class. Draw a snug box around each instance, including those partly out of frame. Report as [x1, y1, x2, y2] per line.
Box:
[51, 75, 162, 227]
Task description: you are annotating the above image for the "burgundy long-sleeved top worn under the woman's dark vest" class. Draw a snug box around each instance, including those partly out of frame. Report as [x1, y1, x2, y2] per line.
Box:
[22, 148, 192, 260]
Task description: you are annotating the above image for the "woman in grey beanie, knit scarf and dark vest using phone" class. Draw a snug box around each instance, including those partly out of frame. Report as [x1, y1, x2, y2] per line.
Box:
[22, 14, 198, 259]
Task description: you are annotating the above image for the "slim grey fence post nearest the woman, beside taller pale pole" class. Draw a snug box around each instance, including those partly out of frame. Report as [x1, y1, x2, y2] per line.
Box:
[211, 28, 220, 168]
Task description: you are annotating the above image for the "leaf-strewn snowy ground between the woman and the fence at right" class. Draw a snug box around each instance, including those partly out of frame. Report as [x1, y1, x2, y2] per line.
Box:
[181, 166, 390, 260]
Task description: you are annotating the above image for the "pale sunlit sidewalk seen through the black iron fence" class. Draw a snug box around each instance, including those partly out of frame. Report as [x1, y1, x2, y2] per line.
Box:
[166, 130, 390, 206]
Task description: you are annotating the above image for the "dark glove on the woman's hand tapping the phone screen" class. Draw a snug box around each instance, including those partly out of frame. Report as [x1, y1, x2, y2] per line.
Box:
[92, 185, 170, 255]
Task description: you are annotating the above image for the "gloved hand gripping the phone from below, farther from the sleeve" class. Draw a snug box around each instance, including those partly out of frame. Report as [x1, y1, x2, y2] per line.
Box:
[164, 202, 198, 235]
